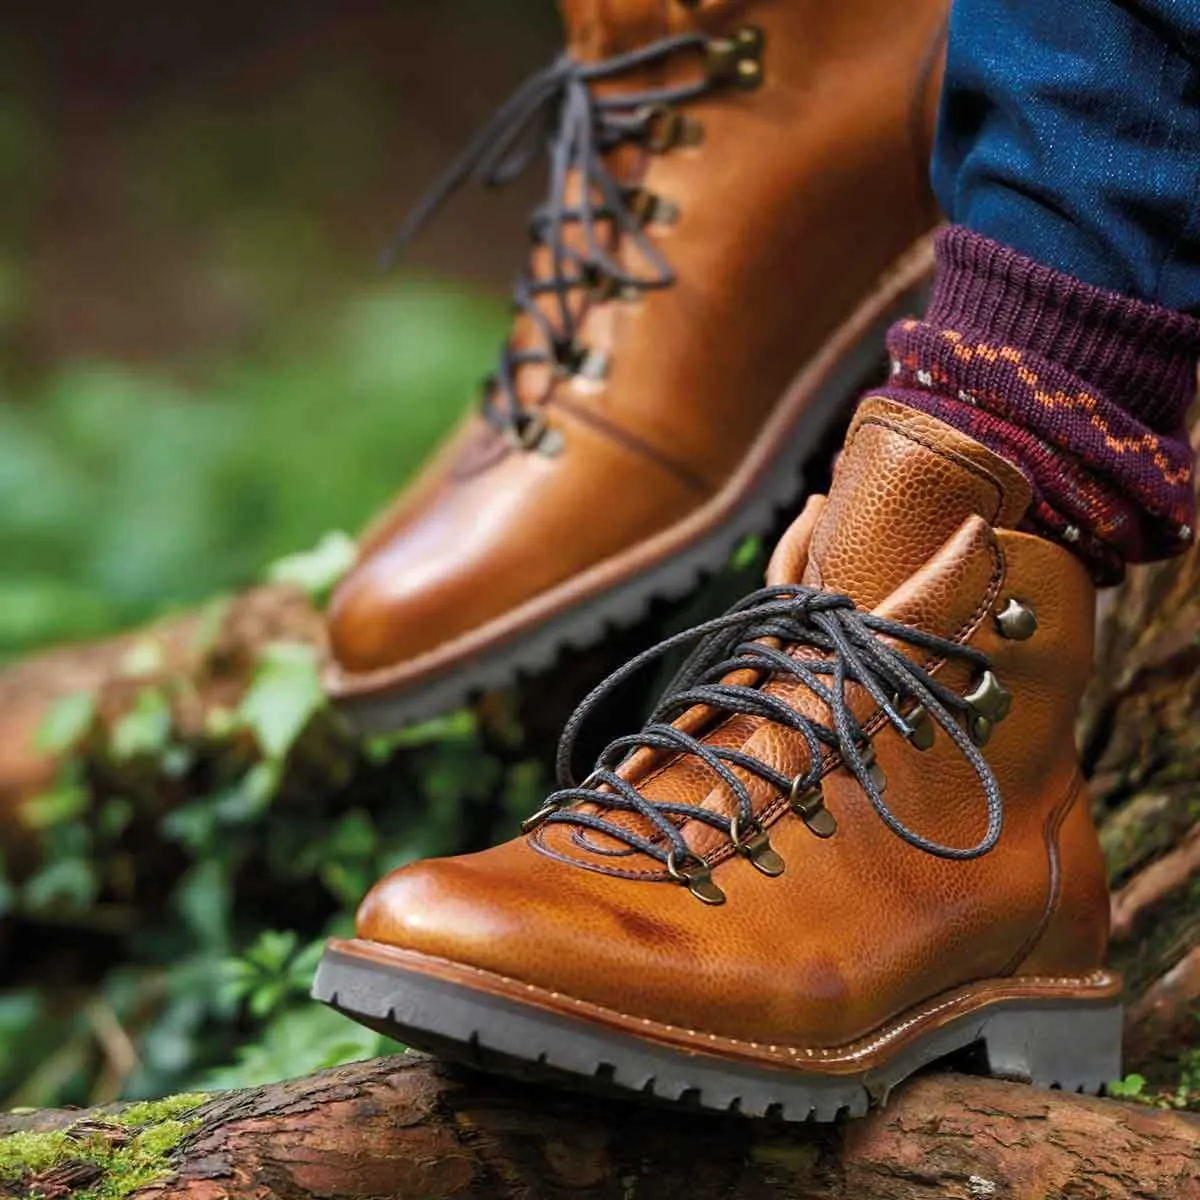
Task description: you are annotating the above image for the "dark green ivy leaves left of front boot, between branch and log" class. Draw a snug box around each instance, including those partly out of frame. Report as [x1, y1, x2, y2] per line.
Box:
[0, 643, 544, 1108]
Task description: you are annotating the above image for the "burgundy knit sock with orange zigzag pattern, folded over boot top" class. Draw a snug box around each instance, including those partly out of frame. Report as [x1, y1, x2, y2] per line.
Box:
[883, 227, 1200, 583]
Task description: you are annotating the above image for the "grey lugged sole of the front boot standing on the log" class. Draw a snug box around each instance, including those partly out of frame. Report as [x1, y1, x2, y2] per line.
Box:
[313, 949, 1122, 1121]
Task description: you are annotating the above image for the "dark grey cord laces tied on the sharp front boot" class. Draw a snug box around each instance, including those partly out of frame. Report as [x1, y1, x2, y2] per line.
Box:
[536, 586, 1003, 869]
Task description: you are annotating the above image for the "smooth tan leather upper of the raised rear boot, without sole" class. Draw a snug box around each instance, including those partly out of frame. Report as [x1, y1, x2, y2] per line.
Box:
[330, 0, 948, 681]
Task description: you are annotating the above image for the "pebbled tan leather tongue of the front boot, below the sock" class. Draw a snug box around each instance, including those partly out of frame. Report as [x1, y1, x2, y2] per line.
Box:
[803, 396, 1031, 608]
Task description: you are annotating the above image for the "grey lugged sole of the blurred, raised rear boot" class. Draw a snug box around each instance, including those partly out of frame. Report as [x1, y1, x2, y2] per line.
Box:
[335, 283, 925, 734]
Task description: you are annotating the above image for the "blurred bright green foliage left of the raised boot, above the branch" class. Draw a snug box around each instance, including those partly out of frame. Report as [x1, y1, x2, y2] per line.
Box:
[0, 281, 503, 656]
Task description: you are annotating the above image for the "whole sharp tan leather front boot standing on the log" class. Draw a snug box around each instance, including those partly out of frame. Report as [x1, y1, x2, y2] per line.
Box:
[314, 400, 1121, 1120]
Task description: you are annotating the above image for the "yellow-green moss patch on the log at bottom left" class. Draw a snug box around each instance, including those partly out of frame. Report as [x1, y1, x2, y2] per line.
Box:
[0, 1094, 206, 1200]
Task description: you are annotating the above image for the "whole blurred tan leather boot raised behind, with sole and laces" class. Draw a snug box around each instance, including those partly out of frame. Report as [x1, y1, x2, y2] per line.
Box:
[329, 0, 948, 728]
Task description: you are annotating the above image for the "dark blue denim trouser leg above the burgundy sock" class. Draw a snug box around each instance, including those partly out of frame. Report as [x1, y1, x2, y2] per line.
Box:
[932, 0, 1200, 314]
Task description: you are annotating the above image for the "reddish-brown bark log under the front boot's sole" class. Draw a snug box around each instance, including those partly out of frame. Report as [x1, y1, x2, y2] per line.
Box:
[0, 1055, 1200, 1200]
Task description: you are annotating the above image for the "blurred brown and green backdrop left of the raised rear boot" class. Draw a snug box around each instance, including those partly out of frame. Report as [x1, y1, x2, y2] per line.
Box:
[0, 0, 558, 658]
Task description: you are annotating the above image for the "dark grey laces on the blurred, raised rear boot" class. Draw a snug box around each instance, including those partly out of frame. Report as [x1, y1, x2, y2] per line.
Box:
[384, 34, 713, 436]
